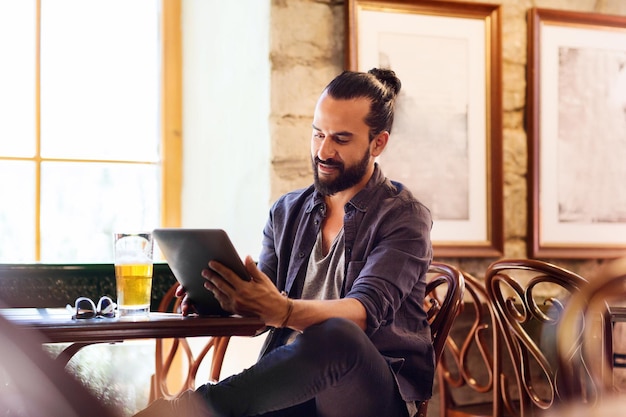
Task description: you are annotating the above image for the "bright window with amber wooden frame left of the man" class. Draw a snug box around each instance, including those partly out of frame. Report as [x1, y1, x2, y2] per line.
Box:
[0, 0, 181, 263]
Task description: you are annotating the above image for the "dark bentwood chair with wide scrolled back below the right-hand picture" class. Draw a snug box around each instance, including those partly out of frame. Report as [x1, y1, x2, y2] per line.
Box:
[485, 259, 587, 417]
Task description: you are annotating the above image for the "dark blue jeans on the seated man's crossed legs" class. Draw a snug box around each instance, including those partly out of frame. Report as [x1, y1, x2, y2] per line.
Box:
[196, 318, 408, 417]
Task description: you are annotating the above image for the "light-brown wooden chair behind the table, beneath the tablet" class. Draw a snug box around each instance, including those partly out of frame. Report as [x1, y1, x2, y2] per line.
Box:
[150, 283, 230, 401]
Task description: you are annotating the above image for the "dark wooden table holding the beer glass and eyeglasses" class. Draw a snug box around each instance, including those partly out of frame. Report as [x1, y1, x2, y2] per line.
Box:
[0, 308, 265, 363]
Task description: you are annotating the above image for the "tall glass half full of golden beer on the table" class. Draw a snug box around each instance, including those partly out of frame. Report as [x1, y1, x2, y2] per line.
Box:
[115, 232, 154, 317]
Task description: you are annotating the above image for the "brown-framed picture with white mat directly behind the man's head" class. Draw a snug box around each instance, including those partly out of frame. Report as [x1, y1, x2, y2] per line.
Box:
[346, 0, 504, 257]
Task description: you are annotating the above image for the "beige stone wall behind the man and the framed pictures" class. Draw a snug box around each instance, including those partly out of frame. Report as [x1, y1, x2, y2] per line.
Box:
[270, 0, 626, 277]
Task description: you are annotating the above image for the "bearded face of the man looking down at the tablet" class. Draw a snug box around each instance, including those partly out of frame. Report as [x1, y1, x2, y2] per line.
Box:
[311, 92, 374, 195]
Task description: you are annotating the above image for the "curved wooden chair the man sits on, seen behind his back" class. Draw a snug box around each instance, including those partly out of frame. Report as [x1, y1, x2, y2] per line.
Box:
[417, 262, 465, 417]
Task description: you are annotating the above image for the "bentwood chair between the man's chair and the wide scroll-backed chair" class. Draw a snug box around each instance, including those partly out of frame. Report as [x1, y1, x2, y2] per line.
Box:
[437, 272, 511, 417]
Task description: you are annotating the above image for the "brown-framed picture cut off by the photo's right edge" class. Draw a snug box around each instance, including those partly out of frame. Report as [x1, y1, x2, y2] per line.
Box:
[527, 8, 626, 258]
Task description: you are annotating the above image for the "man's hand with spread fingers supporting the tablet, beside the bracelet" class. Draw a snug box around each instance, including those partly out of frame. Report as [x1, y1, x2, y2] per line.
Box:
[200, 256, 289, 327]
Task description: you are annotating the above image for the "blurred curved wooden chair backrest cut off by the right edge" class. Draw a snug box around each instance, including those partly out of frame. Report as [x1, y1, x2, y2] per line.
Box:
[557, 258, 626, 403]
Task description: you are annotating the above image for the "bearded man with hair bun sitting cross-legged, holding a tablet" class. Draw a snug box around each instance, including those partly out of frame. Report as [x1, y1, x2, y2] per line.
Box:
[137, 69, 434, 417]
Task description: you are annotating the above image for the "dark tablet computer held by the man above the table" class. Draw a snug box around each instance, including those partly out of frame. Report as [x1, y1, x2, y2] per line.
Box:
[153, 228, 250, 316]
